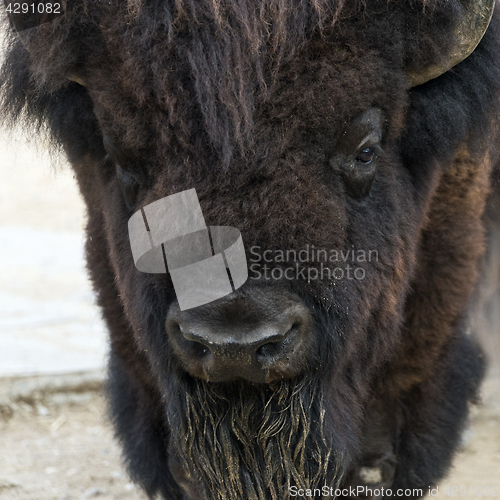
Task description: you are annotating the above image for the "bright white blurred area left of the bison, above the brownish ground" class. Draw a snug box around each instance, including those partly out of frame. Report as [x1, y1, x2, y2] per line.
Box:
[0, 131, 107, 376]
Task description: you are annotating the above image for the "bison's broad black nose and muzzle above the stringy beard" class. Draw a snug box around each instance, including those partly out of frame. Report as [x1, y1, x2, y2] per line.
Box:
[166, 291, 311, 383]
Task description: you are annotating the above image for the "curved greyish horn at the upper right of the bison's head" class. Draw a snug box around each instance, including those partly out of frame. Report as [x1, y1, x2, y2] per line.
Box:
[406, 0, 495, 87]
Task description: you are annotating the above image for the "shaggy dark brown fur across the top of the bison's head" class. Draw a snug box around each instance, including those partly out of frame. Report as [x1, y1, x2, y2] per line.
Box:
[3, 0, 484, 170]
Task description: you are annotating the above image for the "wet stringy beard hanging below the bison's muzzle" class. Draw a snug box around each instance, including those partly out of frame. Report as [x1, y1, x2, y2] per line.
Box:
[167, 377, 343, 500]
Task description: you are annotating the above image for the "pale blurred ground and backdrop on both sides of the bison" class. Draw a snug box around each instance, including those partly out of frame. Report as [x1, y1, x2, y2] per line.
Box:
[0, 131, 500, 500]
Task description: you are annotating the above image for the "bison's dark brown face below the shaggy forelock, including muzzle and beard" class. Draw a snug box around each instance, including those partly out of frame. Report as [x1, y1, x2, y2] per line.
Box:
[83, 49, 418, 500]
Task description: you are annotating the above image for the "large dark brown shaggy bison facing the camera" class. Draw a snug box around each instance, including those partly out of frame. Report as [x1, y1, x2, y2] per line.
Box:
[1, 0, 500, 500]
